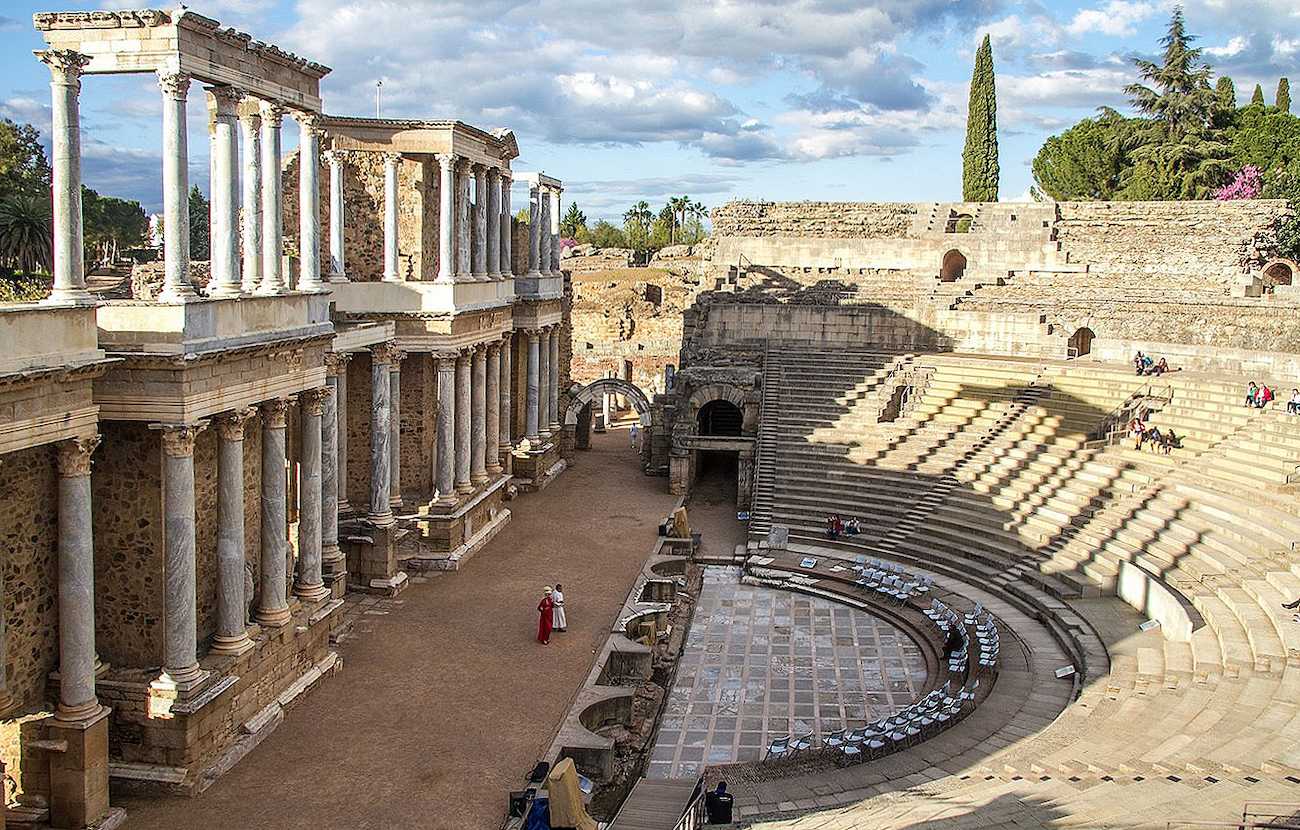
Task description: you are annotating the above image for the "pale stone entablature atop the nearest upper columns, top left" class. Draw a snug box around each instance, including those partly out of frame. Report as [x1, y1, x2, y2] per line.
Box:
[33, 8, 330, 112]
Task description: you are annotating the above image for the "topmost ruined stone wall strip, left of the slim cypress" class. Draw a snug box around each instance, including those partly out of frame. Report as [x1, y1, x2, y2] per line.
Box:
[712, 202, 920, 238]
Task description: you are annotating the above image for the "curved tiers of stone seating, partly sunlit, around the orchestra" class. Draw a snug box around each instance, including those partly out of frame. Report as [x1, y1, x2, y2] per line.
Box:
[737, 349, 1300, 829]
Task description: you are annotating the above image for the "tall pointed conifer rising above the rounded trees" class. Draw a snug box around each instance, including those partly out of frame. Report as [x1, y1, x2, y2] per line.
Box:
[1125, 7, 1231, 199]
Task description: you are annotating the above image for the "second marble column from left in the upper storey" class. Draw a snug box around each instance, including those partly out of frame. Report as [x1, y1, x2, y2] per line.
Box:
[157, 72, 196, 303]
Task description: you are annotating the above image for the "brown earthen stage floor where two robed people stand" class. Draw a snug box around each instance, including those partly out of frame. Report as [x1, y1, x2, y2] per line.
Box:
[120, 429, 673, 830]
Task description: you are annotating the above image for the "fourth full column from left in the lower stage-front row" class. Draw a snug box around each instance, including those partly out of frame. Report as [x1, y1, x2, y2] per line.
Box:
[254, 398, 291, 628]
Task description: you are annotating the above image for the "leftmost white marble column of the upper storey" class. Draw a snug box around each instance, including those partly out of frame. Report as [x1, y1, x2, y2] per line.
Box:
[36, 49, 95, 304]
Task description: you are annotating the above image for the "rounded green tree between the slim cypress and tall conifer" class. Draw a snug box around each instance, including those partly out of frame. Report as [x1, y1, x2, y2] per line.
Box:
[1031, 109, 1141, 202]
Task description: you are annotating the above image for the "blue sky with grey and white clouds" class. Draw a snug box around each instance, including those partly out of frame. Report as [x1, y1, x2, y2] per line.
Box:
[0, 0, 1300, 217]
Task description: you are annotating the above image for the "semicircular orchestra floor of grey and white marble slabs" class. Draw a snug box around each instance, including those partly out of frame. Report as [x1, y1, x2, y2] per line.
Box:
[646, 567, 926, 778]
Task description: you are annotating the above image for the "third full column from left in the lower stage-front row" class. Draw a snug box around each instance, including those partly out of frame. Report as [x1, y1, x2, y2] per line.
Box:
[212, 408, 256, 654]
